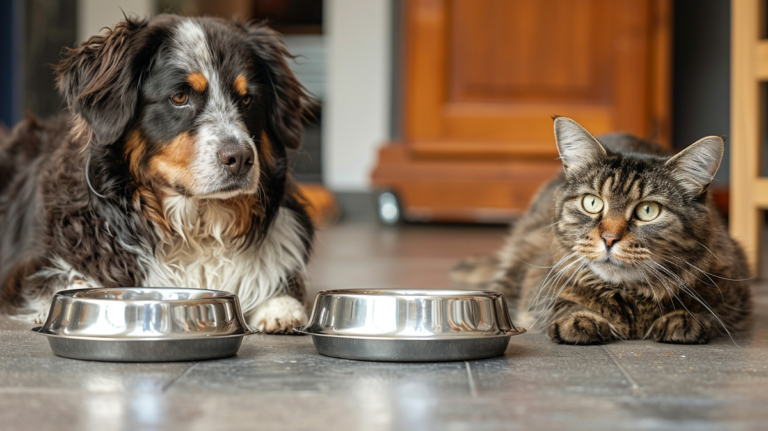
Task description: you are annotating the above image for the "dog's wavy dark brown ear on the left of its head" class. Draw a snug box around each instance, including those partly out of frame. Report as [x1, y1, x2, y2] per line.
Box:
[56, 17, 156, 144]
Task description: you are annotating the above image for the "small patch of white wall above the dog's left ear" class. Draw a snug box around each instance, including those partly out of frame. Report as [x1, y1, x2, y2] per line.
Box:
[77, 0, 155, 42]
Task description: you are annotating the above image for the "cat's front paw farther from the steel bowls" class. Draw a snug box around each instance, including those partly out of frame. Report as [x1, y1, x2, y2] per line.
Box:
[650, 310, 712, 344]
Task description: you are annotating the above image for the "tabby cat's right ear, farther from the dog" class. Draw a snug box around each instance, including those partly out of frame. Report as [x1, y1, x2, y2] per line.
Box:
[666, 136, 725, 196]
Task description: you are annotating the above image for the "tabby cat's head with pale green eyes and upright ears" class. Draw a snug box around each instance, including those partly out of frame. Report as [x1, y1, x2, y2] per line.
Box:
[555, 117, 724, 284]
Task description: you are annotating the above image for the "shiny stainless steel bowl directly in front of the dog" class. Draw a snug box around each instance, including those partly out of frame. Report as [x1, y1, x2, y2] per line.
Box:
[33, 287, 258, 362]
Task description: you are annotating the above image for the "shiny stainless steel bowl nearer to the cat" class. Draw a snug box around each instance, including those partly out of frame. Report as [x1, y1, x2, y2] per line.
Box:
[295, 290, 525, 361]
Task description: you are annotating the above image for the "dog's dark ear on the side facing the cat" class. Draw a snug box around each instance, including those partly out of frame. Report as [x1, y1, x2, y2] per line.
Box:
[238, 21, 315, 149]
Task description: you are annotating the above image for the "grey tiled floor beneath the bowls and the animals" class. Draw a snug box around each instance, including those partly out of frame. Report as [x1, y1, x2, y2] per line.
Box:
[0, 225, 768, 431]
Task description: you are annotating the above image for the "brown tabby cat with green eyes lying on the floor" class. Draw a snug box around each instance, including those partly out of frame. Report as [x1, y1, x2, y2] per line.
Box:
[452, 117, 752, 344]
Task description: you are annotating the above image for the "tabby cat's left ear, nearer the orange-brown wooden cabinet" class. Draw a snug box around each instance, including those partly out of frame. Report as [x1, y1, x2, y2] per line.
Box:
[555, 117, 607, 174]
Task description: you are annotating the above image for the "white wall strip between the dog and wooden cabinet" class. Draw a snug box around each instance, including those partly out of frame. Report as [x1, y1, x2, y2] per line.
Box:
[322, 0, 392, 191]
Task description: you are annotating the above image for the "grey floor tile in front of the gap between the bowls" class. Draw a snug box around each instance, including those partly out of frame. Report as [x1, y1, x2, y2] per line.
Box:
[171, 336, 470, 396]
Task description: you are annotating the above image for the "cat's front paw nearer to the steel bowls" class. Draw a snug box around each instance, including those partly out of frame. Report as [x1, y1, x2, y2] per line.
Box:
[549, 311, 614, 344]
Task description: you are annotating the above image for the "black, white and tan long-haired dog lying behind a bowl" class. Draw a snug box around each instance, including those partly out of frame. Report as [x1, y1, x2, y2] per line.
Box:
[0, 15, 314, 333]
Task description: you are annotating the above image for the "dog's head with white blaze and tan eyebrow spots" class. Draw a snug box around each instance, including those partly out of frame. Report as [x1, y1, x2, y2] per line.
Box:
[57, 15, 311, 204]
